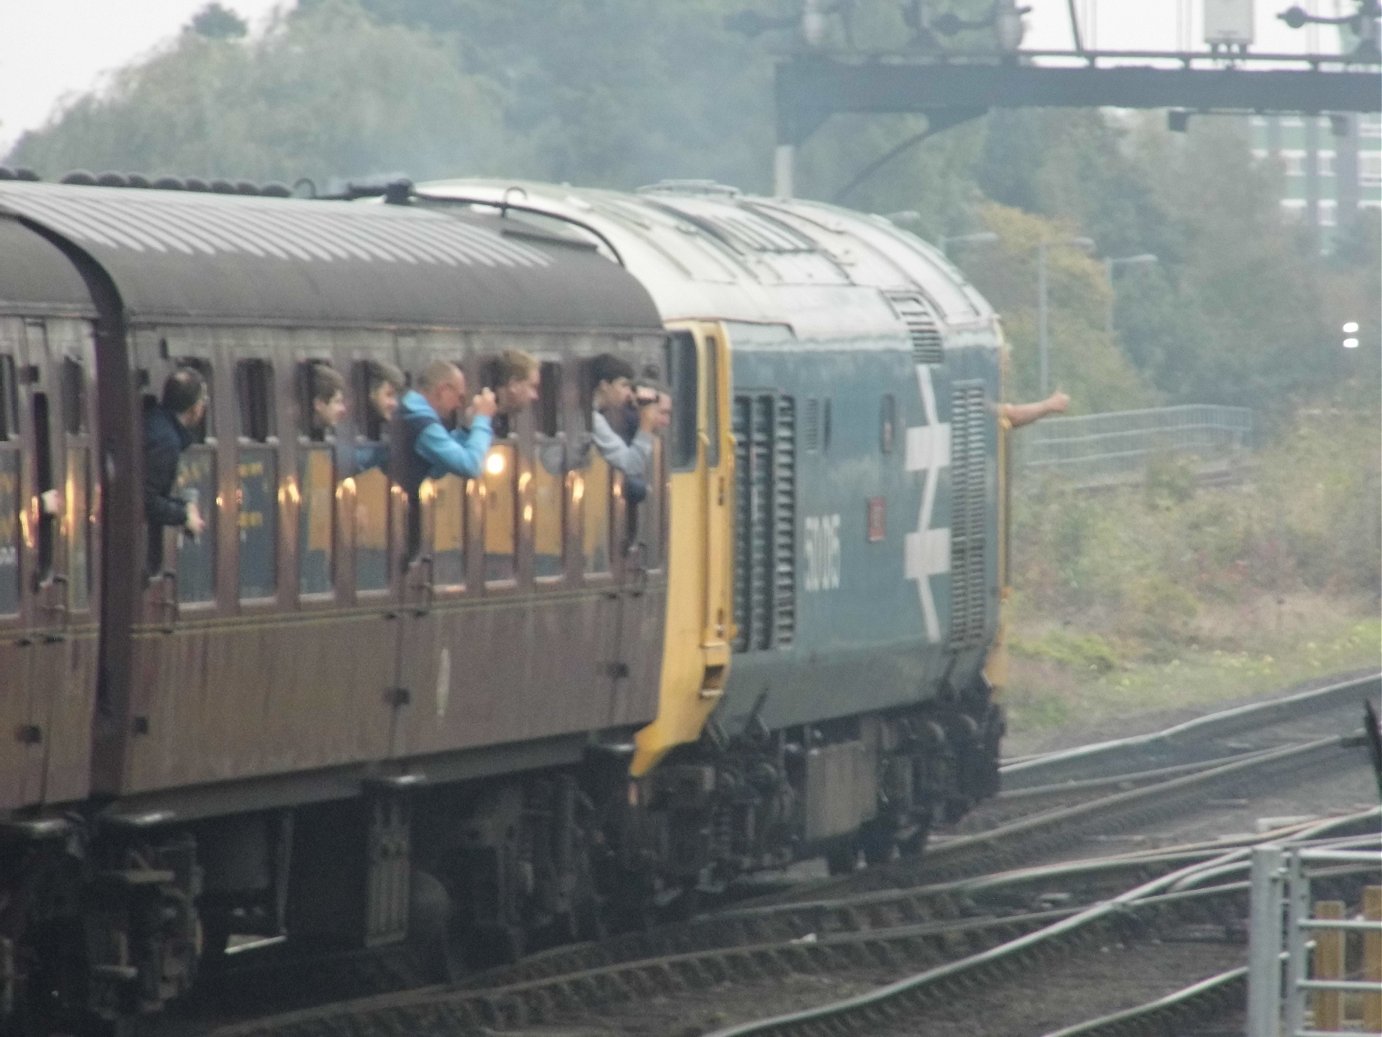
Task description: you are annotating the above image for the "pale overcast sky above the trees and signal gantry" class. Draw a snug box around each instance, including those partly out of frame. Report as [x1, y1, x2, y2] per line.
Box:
[0, 0, 1354, 155]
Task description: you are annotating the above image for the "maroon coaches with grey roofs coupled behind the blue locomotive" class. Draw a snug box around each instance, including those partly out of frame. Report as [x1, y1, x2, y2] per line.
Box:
[0, 181, 666, 1030]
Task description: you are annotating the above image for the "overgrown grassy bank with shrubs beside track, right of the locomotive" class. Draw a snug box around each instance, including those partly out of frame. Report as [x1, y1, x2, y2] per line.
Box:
[1003, 412, 1382, 754]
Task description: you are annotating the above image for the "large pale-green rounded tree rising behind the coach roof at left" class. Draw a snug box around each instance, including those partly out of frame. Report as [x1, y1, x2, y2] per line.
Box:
[11, 0, 513, 181]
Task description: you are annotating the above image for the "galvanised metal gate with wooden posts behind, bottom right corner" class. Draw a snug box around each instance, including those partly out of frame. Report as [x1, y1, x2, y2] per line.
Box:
[1247, 837, 1382, 1037]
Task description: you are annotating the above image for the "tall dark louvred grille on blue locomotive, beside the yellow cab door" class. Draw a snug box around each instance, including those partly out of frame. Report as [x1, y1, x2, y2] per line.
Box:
[734, 393, 796, 651]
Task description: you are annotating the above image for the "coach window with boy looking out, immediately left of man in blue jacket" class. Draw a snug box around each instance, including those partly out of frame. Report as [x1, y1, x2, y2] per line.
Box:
[351, 359, 395, 593]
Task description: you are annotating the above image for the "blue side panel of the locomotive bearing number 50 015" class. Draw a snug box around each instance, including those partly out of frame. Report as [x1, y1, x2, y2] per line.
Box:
[724, 316, 948, 730]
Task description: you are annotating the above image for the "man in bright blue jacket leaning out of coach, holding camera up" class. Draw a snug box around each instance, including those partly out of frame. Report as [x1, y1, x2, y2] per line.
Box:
[398, 359, 495, 554]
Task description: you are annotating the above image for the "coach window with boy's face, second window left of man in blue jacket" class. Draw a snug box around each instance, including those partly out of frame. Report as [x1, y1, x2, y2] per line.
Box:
[297, 361, 337, 595]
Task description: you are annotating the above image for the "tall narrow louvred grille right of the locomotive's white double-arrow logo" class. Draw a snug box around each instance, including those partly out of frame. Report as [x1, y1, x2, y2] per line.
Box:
[949, 382, 988, 648]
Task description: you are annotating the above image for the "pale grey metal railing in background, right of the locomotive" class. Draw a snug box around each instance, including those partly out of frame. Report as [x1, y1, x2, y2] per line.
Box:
[1013, 404, 1252, 485]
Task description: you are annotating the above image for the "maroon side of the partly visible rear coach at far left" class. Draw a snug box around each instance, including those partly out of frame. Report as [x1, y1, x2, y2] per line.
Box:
[0, 319, 98, 806]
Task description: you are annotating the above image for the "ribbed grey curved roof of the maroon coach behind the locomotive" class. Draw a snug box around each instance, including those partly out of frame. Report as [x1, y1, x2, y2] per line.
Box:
[0, 181, 659, 329]
